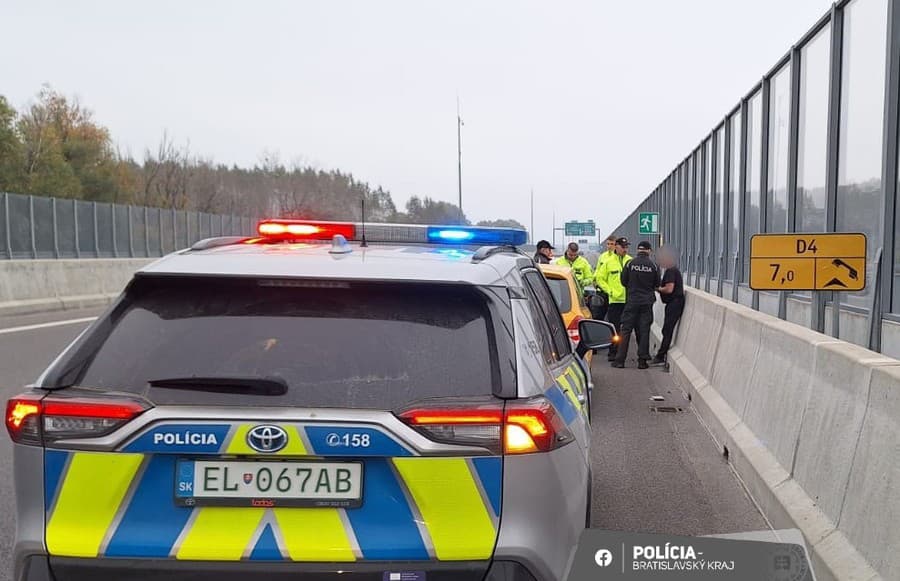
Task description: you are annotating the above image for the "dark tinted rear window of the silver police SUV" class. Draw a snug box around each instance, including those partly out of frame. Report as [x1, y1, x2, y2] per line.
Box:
[67, 278, 496, 409]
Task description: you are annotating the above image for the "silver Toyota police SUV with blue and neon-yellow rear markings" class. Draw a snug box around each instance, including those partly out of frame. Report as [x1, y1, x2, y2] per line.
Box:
[7, 220, 612, 581]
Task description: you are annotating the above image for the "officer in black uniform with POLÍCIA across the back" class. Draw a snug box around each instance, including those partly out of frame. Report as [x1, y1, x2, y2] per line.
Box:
[612, 241, 661, 369]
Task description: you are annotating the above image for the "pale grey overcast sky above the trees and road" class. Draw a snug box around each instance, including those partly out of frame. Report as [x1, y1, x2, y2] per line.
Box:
[0, 0, 831, 238]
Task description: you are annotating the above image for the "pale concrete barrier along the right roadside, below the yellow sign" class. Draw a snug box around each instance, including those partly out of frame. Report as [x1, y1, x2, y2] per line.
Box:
[654, 289, 900, 581]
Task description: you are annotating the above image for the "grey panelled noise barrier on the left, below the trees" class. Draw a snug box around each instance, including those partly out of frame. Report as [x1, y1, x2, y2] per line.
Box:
[0, 193, 256, 259]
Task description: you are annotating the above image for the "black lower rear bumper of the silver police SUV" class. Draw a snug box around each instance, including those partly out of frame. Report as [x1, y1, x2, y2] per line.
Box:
[22, 555, 536, 581]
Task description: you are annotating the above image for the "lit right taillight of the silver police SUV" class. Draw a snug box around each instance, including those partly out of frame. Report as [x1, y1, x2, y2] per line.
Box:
[400, 397, 573, 454]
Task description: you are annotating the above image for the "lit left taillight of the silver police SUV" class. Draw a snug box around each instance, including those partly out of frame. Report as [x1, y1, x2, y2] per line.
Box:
[6, 394, 149, 444]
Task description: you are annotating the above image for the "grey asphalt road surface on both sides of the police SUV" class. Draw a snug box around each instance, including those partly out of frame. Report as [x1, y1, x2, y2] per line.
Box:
[0, 309, 768, 581]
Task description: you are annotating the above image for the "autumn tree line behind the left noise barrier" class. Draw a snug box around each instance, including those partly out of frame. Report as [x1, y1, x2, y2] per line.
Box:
[0, 86, 524, 228]
